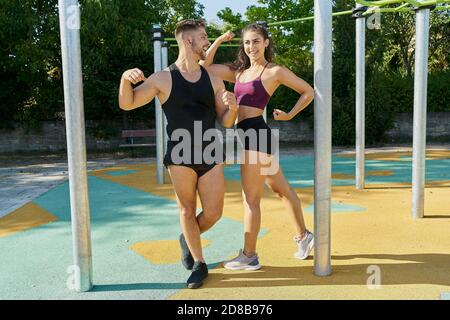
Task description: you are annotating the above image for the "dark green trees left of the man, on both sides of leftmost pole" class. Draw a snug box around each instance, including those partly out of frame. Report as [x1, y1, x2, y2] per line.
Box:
[0, 0, 207, 128]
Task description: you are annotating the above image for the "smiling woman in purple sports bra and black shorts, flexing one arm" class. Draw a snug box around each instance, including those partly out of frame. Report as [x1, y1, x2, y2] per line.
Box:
[201, 24, 314, 270]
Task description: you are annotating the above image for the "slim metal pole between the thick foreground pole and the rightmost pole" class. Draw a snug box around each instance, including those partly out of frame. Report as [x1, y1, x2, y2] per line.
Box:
[355, 4, 366, 189]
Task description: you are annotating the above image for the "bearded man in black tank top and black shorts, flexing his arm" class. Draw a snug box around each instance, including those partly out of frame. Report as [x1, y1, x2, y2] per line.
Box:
[119, 20, 238, 289]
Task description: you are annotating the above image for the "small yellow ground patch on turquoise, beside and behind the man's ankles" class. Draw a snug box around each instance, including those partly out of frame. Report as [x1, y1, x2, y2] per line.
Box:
[130, 239, 210, 264]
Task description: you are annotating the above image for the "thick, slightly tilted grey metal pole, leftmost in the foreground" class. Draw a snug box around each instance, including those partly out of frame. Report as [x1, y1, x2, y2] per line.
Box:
[58, 0, 92, 292]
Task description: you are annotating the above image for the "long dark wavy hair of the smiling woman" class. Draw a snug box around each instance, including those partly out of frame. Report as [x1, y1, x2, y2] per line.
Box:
[229, 23, 274, 73]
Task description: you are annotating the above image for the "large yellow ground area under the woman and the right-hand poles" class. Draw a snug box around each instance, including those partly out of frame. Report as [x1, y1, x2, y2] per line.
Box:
[171, 186, 450, 300]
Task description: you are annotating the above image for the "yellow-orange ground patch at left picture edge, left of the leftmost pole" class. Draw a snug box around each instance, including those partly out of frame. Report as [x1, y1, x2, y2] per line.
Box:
[0, 202, 58, 237]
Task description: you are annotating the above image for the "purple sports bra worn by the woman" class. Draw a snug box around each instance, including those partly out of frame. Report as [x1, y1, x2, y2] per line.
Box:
[234, 63, 270, 110]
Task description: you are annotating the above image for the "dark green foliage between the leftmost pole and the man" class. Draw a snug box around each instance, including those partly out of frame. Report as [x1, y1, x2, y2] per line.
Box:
[80, 0, 162, 121]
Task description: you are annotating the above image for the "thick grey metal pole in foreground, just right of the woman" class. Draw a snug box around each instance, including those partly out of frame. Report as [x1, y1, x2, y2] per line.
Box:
[314, 0, 332, 276]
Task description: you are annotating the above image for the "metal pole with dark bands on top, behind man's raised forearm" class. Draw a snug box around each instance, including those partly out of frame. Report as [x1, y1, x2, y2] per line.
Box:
[153, 24, 164, 184]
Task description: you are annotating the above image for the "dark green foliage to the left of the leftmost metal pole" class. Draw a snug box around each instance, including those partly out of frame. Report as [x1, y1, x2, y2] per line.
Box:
[0, 0, 59, 128]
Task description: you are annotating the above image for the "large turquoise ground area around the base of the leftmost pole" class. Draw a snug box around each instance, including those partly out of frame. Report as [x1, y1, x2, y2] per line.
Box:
[0, 177, 267, 299]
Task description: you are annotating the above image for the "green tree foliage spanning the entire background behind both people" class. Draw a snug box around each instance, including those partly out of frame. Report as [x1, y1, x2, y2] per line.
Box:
[0, 0, 450, 144]
